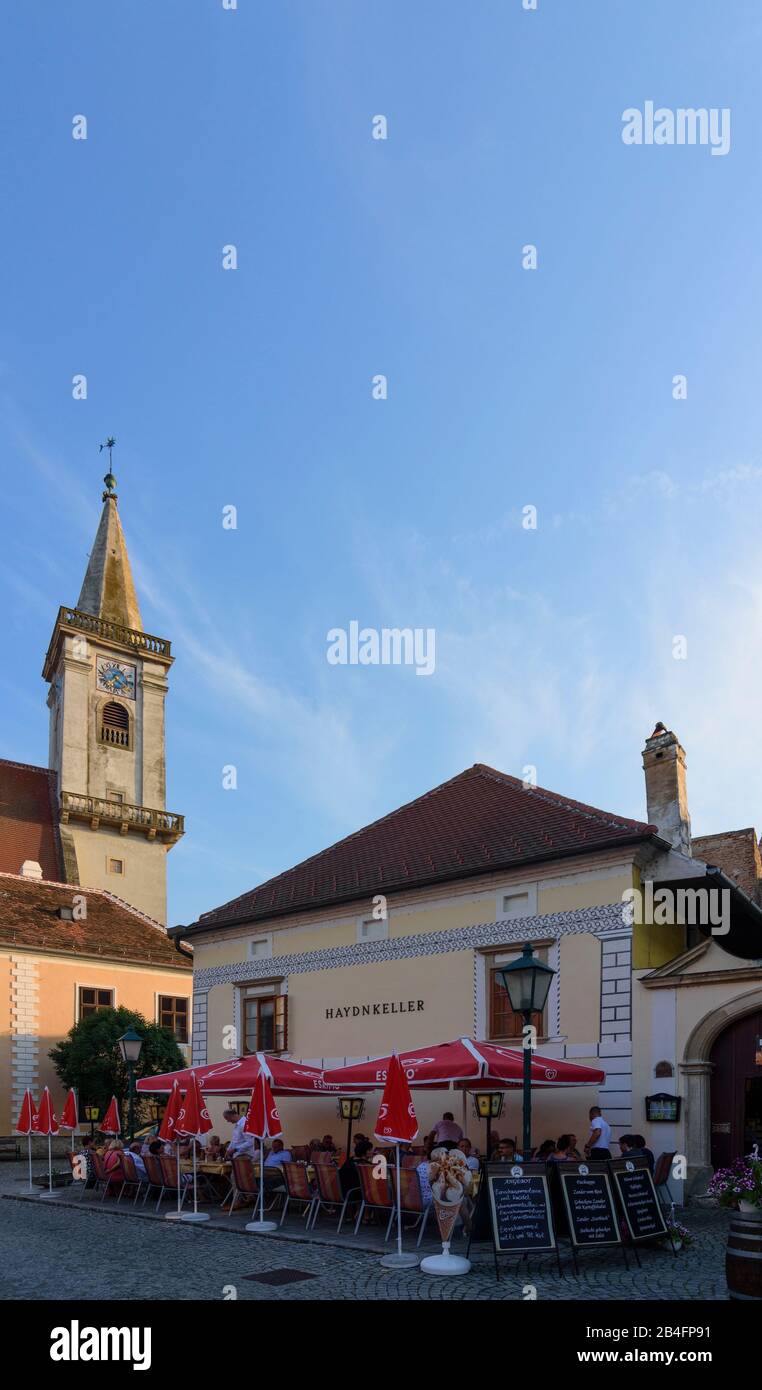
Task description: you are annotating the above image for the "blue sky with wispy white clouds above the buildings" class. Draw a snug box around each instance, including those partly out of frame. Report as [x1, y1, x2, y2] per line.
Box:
[0, 0, 762, 922]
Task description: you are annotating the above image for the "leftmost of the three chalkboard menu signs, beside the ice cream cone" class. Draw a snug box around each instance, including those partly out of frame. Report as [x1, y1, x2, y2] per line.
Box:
[485, 1163, 556, 1255]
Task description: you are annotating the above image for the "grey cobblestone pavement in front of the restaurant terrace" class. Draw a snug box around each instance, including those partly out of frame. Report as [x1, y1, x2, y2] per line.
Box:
[0, 1163, 727, 1301]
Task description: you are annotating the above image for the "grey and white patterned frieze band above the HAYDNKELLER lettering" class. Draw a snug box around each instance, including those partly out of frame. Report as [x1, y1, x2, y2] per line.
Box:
[193, 902, 623, 990]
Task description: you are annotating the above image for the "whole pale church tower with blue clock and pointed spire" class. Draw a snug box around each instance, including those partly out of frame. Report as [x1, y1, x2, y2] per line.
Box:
[43, 470, 184, 923]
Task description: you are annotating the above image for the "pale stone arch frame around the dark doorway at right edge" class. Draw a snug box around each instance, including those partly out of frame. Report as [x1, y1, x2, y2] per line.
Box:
[680, 986, 762, 1193]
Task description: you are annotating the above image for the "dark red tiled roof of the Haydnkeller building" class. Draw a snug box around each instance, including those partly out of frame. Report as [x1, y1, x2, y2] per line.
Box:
[197, 763, 656, 927]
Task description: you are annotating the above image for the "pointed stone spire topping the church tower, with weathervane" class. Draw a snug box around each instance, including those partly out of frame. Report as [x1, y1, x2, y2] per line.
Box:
[76, 439, 143, 632]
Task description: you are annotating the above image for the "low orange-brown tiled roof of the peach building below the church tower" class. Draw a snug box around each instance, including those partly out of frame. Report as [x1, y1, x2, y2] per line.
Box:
[0, 873, 192, 970]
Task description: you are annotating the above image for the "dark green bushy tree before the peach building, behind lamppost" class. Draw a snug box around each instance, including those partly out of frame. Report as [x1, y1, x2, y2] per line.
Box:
[49, 1009, 188, 1118]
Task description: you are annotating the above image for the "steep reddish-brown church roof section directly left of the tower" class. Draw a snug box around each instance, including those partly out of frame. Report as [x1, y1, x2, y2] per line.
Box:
[0, 758, 65, 880]
